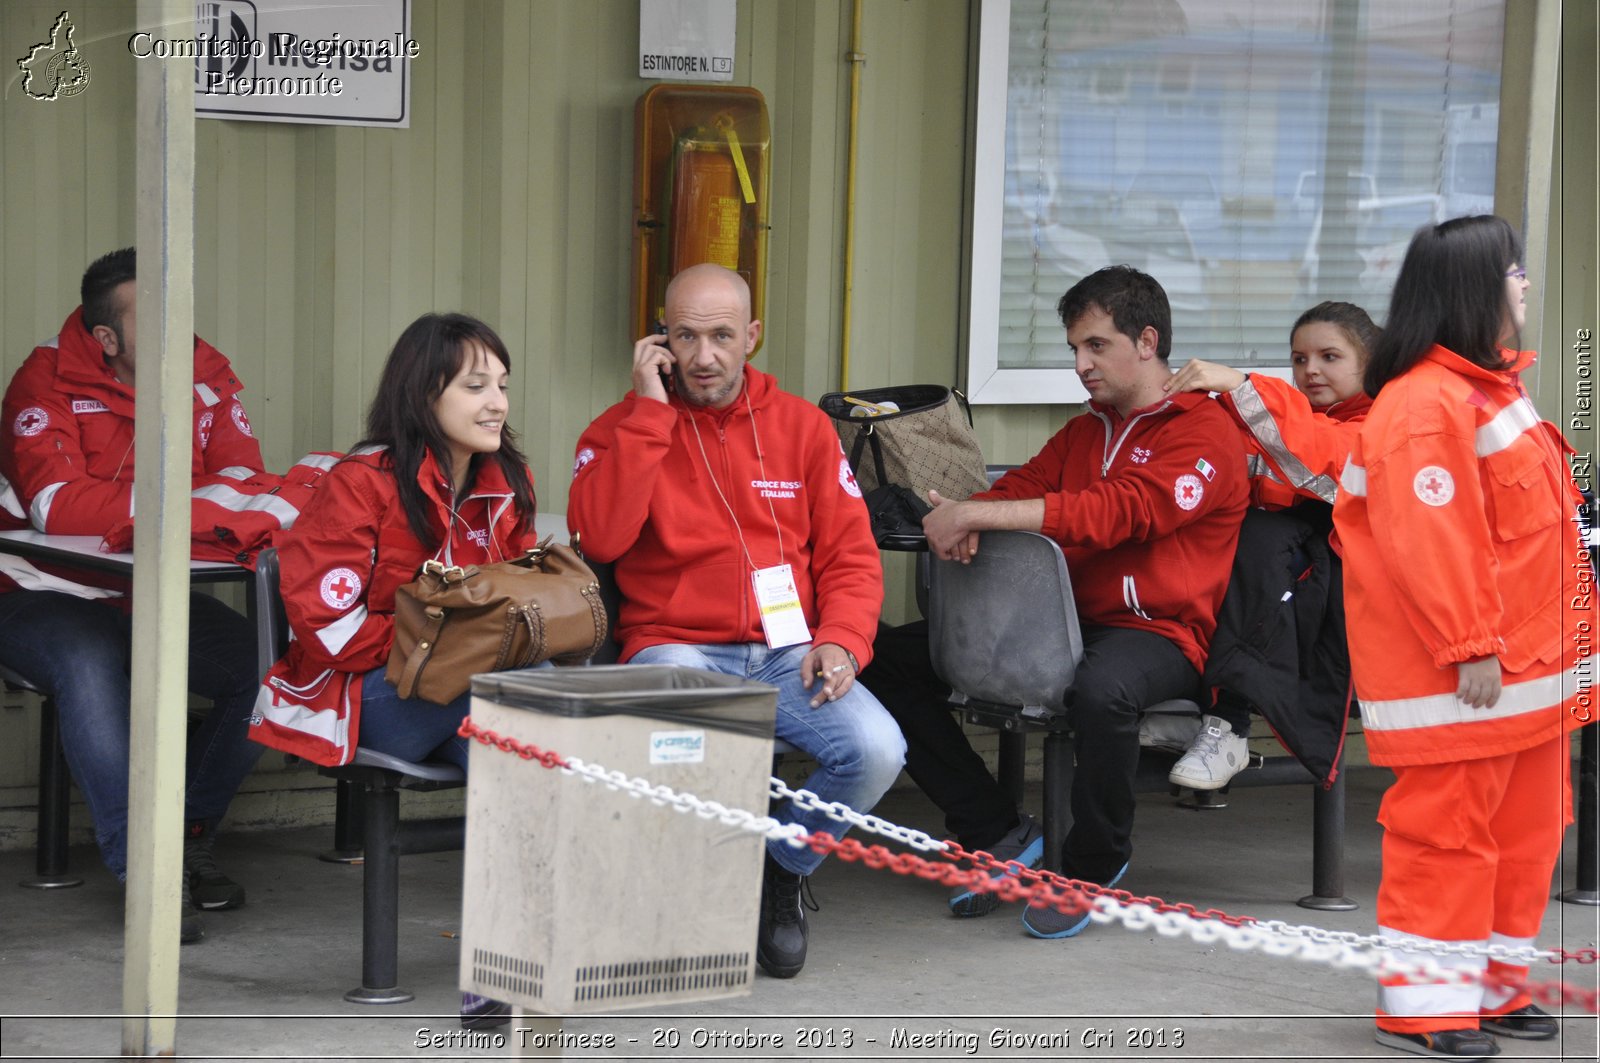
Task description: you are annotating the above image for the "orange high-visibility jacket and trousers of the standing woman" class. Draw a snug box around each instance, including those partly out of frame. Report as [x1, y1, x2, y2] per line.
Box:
[1333, 347, 1595, 1033]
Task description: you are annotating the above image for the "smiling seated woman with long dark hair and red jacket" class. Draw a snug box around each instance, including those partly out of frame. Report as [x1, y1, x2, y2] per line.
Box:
[251, 314, 538, 1026]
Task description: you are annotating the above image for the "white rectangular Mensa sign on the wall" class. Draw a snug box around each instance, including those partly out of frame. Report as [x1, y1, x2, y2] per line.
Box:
[166, 0, 422, 128]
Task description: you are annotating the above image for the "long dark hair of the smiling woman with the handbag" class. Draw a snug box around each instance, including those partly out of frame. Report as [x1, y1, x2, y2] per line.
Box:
[355, 314, 536, 549]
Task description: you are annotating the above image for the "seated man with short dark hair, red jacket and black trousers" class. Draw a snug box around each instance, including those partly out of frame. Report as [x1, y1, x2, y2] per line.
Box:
[915, 266, 1250, 938]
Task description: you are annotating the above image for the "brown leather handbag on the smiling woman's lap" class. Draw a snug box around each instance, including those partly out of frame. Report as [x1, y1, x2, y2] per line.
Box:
[384, 538, 606, 704]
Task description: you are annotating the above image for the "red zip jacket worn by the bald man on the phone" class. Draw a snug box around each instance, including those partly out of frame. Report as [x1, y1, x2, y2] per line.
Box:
[566, 365, 883, 668]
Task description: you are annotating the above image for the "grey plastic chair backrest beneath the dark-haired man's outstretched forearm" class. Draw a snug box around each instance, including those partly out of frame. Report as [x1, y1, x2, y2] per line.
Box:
[928, 532, 1083, 712]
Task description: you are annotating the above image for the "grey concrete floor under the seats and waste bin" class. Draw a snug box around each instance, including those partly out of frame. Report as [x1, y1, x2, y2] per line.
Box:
[0, 768, 1600, 1060]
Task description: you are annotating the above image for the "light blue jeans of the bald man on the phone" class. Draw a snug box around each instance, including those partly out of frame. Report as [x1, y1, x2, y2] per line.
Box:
[630, 642, 906, 874]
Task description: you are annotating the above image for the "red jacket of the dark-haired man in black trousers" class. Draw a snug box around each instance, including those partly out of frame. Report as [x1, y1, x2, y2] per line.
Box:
[973, 392, 1250, 671]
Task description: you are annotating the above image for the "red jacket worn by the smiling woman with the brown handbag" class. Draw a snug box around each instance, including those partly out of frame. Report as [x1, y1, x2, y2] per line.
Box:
[250, 447, 538, 765]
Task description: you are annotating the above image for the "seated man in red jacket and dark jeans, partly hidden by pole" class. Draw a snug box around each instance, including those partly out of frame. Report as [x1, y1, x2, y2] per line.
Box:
[0, 248, 262, 943]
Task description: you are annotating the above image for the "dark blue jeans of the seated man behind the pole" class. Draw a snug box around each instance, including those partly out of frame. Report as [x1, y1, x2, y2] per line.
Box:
[0, 591, 261, 877]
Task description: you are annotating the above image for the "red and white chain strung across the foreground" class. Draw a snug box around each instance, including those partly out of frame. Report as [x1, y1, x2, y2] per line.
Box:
[459, 717, 1600, 1012]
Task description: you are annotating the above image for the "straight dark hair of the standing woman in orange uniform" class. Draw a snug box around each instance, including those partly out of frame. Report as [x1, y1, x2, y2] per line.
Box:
[1363, 215, 1522, 395]
